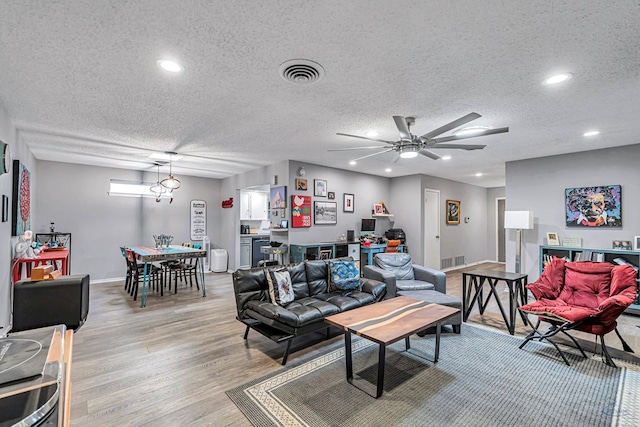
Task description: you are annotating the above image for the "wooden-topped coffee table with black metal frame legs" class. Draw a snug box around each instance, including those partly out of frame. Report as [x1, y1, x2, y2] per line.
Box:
[325, 296, 460, 398]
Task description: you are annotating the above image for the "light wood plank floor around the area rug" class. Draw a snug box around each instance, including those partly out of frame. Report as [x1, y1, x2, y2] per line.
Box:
[71, 264, 640, 426]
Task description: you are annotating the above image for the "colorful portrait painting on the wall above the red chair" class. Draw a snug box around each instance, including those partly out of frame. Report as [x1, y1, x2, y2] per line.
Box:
[564, 185, 622, 227]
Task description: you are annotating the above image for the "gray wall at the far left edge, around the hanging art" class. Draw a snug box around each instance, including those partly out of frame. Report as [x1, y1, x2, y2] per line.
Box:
[0, 102, 38, 335]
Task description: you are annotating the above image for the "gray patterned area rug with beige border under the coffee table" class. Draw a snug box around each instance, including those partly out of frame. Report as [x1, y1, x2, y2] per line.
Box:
[227, 324, 640, 427]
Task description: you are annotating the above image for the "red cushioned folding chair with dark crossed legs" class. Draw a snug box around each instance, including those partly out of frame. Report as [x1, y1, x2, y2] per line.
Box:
[518, 258, 638, 367]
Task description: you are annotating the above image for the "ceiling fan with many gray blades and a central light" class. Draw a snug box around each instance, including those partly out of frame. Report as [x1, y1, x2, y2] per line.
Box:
[328, 113, 509, 163]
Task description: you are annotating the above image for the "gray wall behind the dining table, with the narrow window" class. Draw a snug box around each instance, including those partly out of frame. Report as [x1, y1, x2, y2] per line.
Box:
[33, 161, 221, 281]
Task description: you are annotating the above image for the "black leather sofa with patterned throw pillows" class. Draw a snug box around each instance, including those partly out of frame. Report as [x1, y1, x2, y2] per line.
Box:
[233, 260, 386, 365]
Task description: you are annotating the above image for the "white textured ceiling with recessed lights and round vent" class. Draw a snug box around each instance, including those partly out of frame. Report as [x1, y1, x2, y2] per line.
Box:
[0, 0, 640, 187]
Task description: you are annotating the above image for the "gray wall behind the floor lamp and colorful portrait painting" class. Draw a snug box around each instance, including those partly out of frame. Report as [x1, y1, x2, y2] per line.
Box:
[506, 144, 640, 281]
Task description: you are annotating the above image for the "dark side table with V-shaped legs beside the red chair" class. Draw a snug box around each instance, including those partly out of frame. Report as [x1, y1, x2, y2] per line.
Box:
[462, 270, 528, 335]
